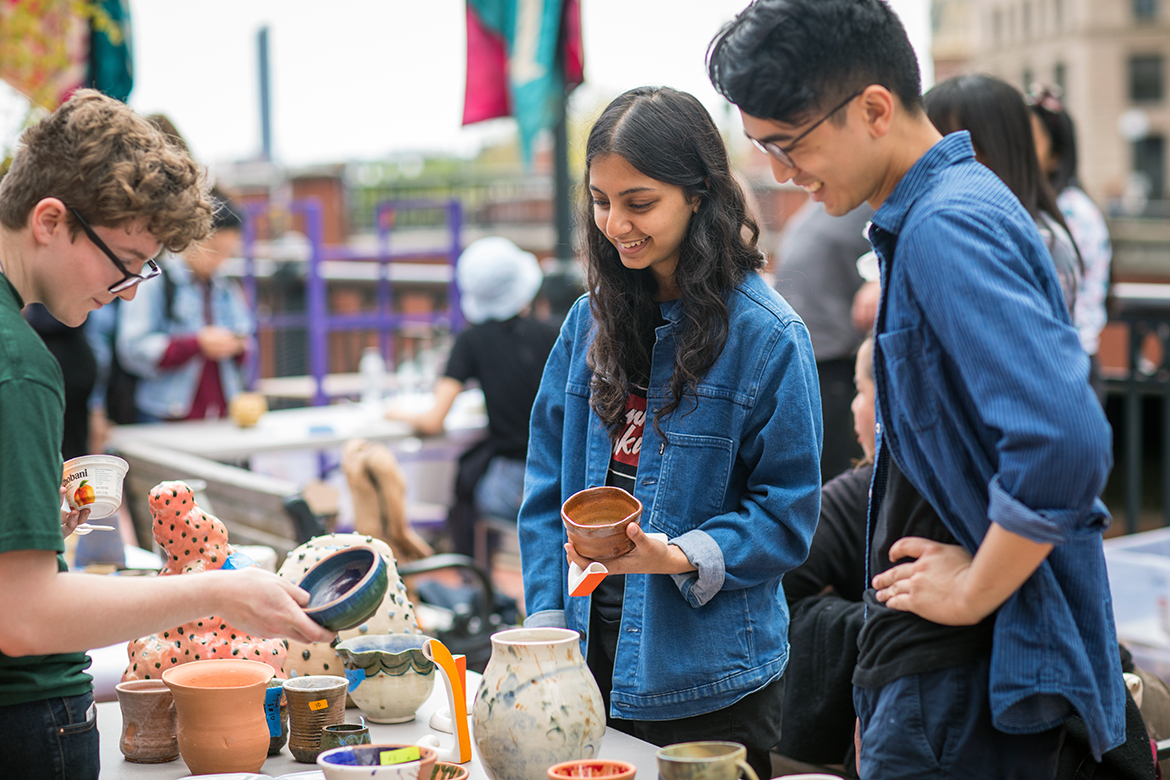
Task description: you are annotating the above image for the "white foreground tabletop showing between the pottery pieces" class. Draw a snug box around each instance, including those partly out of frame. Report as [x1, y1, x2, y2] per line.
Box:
[97, 671, 658, 780]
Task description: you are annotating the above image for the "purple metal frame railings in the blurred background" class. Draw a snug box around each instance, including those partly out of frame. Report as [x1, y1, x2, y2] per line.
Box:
[243, 198, 463, 406]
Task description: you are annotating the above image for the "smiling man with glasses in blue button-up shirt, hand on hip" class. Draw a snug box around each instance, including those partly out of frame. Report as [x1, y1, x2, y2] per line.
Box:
[708, 0, 1127, 780]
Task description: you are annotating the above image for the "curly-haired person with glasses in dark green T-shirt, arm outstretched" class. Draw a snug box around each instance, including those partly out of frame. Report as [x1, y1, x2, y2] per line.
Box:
[0, 90, 332, 780]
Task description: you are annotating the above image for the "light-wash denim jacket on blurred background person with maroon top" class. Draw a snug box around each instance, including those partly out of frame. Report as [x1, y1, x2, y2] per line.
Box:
[116, 255, 255, 417]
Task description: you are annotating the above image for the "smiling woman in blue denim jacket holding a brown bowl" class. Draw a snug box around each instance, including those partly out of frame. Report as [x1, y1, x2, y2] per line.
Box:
[519, 88, 821, 776]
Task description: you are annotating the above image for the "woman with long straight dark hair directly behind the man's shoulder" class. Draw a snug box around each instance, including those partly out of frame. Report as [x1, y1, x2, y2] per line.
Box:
[922, 74, 1081, 313]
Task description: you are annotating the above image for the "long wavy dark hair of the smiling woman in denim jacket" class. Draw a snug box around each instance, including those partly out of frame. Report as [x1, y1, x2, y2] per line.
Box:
[578, 87, 764, 435]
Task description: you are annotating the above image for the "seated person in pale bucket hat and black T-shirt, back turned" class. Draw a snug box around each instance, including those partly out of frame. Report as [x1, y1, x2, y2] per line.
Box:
[386, 236, 559, 555]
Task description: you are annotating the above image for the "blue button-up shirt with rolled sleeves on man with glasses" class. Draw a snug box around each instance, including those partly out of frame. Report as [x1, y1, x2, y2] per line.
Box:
[869, 131, 1124, 757]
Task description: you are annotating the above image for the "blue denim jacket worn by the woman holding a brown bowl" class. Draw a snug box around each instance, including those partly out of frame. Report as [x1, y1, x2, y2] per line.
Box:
[519, 274, 821, 720]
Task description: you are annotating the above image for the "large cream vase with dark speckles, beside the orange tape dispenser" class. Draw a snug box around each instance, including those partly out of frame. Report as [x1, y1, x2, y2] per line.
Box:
[472, 628, 605, 780]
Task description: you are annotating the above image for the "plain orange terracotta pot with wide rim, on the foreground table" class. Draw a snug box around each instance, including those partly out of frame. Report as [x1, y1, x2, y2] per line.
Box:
[163, 658, 275, 774]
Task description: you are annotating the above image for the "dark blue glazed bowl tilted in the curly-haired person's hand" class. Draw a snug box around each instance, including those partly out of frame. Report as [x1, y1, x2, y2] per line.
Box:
[297, 545, 388, 631]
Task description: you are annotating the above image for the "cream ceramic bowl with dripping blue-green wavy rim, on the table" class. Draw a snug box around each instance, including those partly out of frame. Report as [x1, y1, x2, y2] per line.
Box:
[333, 634, 435, 723]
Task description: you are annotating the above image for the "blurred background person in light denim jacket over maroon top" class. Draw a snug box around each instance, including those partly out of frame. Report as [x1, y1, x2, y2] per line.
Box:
[115, 194, 255, 422]
